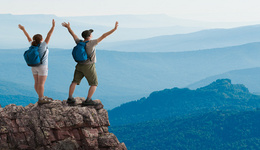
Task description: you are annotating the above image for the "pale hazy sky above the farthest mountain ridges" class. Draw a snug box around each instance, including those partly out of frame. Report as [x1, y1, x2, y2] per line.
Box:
[0, 0, 260, 22]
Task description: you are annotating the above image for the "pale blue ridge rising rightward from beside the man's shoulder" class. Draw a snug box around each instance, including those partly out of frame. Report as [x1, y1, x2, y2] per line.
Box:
[100, 25, 260, 52]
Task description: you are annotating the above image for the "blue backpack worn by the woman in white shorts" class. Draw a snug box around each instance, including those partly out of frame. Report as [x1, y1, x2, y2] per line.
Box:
[23, 44, 46, 67]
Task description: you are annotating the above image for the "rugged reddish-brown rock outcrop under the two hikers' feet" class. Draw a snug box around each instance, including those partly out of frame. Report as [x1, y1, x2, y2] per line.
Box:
[0, 98, 127, 150]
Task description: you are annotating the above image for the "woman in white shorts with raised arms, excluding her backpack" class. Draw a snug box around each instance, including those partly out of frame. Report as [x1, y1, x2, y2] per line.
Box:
[18, 19, 55, 105]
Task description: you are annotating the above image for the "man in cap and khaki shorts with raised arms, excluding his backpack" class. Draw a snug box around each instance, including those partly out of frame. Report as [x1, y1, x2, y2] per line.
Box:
[62, 22, 118, 106]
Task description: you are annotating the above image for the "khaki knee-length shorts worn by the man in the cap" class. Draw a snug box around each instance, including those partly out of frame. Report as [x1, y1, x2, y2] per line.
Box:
[72, 63, 98, 86]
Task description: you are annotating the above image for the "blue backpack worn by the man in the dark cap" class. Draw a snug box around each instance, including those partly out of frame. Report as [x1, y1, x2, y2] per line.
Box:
[72, 41, 93, 63]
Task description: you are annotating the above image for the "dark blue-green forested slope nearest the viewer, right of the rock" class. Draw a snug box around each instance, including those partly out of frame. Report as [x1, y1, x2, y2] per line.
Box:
[109, 110, 260, 150]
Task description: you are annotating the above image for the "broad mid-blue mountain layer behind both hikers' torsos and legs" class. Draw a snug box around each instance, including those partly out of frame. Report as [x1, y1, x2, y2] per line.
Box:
[0, 43, 260, 109]
